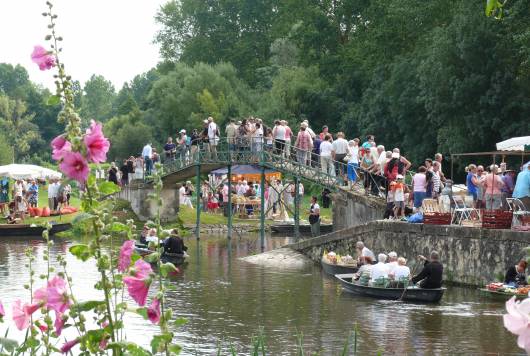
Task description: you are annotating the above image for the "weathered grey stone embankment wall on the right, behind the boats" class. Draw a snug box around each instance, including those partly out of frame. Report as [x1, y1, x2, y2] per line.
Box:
[284, 221, 530, 286]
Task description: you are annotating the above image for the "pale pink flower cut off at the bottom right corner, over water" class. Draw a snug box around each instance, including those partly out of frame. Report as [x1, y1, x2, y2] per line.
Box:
[503, 297, 530, 354]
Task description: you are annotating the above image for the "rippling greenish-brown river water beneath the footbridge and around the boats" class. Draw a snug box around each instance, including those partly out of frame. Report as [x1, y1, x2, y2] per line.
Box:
[0, 235, 524, 355]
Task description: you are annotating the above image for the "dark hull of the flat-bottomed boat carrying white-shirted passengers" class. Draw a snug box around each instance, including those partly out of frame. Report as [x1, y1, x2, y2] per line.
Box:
[335, 273, 445, 303]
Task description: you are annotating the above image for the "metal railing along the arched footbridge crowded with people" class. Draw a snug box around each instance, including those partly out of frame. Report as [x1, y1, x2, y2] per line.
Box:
[146, 137, 385, 197]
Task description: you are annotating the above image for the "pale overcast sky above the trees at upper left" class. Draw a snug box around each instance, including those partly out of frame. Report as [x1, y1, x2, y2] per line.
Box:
[0, 0, 167, 90]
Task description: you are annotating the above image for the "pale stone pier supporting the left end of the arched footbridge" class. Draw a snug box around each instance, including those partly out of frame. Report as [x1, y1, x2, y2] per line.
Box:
[117, 184, 179, 222]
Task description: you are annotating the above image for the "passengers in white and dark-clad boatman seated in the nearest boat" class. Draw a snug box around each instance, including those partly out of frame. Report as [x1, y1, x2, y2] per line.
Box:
[354, 241, 443, 289]
